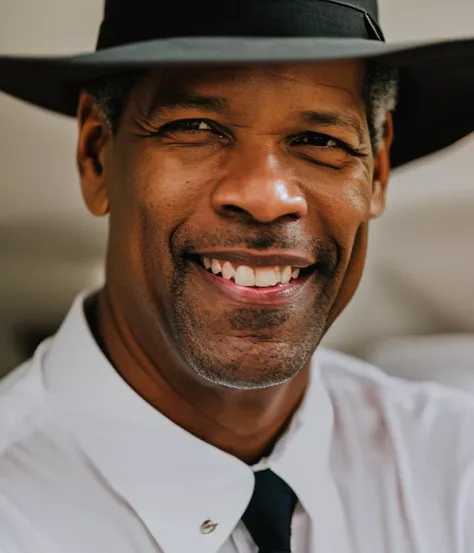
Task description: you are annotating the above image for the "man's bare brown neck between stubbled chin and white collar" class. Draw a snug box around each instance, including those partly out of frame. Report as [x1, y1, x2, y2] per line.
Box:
[89, 289, 309, 463]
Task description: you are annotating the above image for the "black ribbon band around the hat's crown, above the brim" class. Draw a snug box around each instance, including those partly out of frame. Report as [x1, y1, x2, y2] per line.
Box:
[97, 0, 385, 50]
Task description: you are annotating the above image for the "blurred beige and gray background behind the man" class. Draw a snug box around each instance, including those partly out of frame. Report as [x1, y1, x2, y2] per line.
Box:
[0, 0, 474, 392]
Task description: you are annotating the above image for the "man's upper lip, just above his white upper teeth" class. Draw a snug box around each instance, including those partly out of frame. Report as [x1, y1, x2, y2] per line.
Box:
[196, 250, 315, 269]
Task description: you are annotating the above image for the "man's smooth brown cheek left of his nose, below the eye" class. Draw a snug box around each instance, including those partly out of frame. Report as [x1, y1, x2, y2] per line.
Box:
[111, 145, 219, 289]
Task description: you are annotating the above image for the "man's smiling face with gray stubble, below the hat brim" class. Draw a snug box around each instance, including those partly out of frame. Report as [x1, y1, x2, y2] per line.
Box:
[79, 62, 388, 388]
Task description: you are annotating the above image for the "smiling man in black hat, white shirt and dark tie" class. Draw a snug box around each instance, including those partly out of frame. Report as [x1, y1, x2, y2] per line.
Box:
[0, 0, 474, 553]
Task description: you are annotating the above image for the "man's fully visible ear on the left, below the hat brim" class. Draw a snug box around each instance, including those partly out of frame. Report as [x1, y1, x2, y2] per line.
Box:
[77, 92, 112, 216]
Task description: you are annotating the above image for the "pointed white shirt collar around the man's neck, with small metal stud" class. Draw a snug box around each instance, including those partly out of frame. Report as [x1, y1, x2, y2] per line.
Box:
[42, 292, 332, 553]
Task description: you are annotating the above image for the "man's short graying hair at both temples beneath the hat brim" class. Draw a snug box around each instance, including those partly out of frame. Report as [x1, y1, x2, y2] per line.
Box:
[85, 61, 398, 152]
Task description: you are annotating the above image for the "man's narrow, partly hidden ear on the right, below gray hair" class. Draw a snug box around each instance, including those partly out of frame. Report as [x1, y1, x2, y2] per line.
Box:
[370, 113, 393, 219]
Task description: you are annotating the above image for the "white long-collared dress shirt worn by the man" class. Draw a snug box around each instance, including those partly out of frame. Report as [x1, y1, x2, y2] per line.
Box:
[0, 293, 474, 553]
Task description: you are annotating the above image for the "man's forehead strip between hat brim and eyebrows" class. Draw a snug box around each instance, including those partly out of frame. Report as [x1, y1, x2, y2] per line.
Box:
[135, 61, 365, 112]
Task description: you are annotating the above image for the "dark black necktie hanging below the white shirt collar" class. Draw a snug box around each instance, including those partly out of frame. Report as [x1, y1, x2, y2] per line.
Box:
[242, 469, 297, 553]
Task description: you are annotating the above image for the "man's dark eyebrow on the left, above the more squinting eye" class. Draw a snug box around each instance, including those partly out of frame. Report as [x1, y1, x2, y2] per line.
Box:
[147, 89, 229, 119]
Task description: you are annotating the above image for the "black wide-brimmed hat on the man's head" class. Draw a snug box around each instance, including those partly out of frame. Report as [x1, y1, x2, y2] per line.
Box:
[0, 0, 474, 167]
